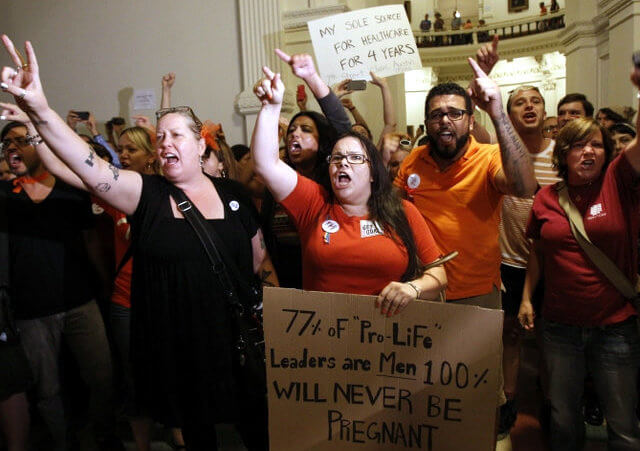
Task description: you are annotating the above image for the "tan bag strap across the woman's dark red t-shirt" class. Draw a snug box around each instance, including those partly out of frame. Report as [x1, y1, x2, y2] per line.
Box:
[558, 183, 638, 299]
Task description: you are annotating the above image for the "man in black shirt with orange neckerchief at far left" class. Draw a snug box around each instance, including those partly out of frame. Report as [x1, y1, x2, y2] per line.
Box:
[0, 121, 124, 450]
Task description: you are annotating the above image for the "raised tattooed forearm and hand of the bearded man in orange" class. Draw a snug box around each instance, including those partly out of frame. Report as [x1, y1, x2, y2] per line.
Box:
[468, 58, 538, 197]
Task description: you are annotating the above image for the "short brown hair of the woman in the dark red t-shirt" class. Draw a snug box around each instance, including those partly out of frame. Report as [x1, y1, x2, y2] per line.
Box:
[553, 117, 615, 182]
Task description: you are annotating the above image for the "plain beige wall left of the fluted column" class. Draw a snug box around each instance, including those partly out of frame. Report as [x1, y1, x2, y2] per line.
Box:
[0, 0, 244, 143]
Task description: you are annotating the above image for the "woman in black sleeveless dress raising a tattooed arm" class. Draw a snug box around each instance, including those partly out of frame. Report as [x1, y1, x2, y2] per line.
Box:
[0, 36, 268, 450]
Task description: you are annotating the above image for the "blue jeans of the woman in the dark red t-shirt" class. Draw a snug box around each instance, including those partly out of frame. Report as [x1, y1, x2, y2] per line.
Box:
[543, 318, 640, 451]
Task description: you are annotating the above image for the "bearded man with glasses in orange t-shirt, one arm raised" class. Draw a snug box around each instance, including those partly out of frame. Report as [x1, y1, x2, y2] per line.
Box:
[394, 59, 537, 442]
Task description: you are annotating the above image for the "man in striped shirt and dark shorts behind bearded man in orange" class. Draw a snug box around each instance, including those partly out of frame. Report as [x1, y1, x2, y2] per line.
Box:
[500, 86, 560, 432]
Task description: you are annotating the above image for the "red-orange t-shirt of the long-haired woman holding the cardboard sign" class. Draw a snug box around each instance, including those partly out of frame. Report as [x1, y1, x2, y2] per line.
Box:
[281, 175, 440, 295]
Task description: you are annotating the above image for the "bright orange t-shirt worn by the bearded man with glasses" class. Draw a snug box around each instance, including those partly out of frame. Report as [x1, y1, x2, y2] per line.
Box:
[394, 137, 503, 299]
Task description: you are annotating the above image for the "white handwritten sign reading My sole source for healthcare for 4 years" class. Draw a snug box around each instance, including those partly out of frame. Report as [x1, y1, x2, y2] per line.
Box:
[307, 5, 422, 85]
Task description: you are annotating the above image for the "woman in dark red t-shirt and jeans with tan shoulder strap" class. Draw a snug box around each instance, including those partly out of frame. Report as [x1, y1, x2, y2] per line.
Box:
[518, 115, 640, 451]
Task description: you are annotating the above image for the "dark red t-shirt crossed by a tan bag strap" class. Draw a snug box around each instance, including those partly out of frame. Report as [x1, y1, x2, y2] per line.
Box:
[527, 152, 640, 326]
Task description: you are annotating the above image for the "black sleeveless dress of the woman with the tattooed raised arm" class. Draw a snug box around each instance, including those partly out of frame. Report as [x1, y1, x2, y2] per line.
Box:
[130, 175, 258, 426]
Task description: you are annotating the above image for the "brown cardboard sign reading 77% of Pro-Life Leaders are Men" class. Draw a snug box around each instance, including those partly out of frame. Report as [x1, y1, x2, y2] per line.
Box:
[264, 288, 502, 451]
